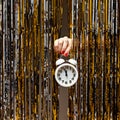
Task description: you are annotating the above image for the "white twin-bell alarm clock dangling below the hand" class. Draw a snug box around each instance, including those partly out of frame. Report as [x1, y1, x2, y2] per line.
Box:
[55, 58, 78, 87]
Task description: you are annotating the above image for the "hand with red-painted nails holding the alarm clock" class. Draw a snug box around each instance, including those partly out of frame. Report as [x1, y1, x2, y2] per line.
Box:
[54, 37, 73, 56]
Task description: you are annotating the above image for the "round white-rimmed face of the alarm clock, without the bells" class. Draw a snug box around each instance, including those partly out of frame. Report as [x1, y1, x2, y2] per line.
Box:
[55, 63, 78, 87]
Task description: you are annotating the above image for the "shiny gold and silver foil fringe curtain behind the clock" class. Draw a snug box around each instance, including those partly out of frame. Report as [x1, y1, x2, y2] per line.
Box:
[0, 0, 120, 120]
